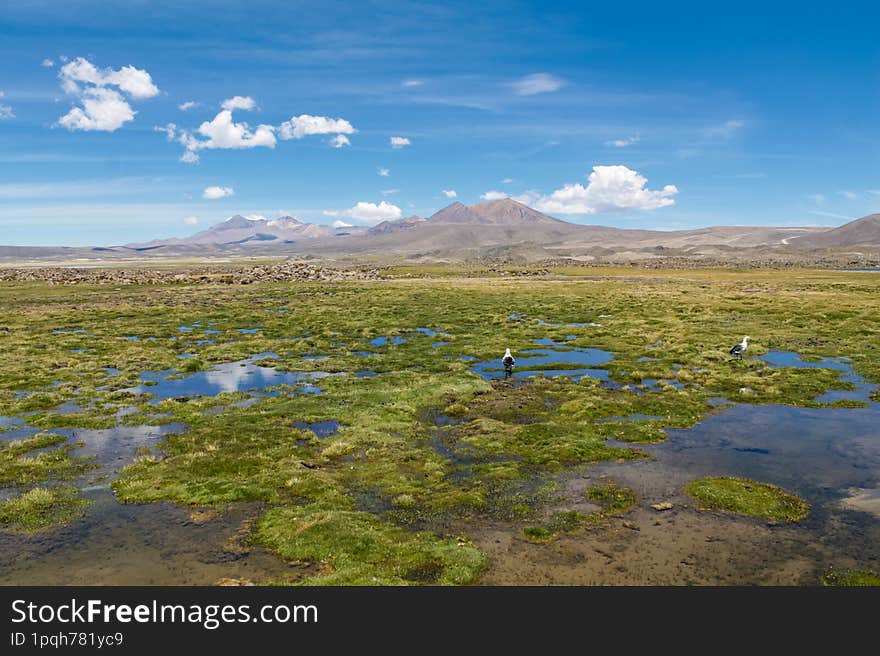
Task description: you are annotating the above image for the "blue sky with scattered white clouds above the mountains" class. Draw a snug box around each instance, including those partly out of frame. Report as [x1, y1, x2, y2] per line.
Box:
[0, 0, 880, 245]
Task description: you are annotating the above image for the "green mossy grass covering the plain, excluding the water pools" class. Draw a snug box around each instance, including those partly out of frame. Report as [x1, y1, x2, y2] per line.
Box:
[0, 267, 880, 584]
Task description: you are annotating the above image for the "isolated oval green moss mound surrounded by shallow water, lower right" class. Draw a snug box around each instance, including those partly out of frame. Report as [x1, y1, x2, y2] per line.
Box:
[685, 476, 810, 522]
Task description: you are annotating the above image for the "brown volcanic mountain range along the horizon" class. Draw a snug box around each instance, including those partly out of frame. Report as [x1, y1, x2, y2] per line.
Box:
[0, 199, 880, 261]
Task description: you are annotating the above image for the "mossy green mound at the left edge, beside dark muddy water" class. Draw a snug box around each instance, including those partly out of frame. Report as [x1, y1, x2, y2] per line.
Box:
[0, 486, 90, 533]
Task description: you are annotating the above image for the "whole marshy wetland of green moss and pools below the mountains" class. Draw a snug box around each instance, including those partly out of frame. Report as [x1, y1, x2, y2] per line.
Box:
[0, 267, 880, 585]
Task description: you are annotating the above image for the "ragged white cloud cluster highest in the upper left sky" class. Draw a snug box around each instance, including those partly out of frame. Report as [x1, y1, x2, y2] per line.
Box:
[58, 57, 159, 132]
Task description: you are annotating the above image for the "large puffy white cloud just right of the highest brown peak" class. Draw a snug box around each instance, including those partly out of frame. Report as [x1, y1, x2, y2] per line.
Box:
[534, 164, 678, 214]
